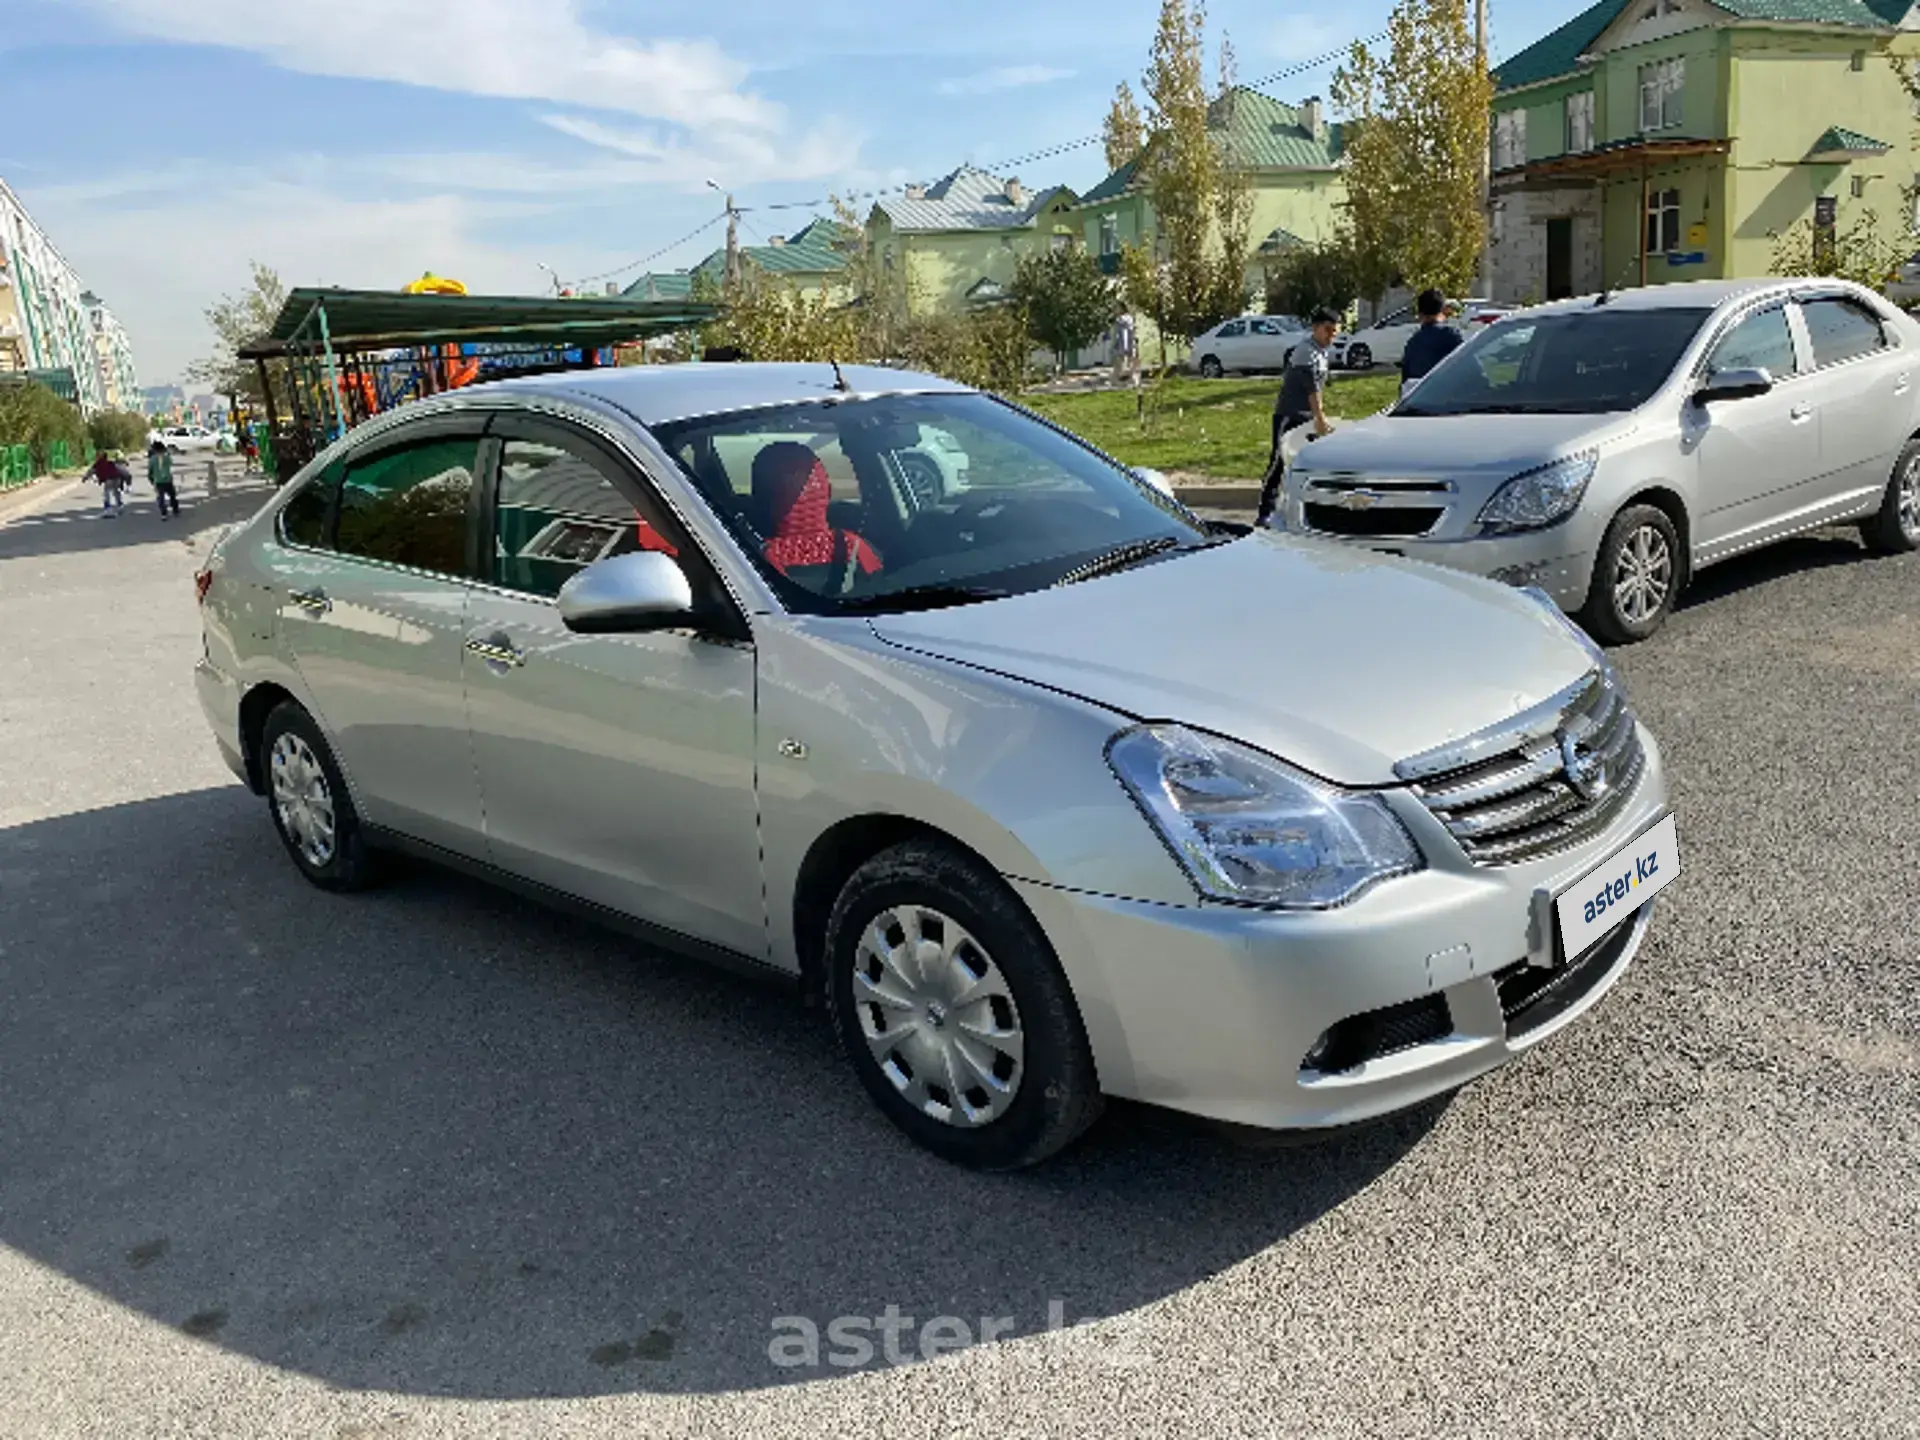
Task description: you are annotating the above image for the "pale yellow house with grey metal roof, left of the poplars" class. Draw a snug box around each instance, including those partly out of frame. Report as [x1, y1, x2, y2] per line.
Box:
[866, 165, 1079, 315]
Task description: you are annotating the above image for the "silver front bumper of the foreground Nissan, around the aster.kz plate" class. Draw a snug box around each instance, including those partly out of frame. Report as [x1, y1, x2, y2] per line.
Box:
[1014, 732, 1667, 1129]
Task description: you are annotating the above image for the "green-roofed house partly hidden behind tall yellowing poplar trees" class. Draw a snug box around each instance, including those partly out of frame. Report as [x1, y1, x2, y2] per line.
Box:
[1077, 86, 1346, 299]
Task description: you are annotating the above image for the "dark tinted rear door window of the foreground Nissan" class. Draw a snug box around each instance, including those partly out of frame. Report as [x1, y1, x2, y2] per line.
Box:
[334, 440, 480, 574]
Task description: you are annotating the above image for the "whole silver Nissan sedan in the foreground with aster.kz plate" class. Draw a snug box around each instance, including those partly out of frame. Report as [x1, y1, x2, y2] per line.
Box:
[196, 365, 1678, 1167]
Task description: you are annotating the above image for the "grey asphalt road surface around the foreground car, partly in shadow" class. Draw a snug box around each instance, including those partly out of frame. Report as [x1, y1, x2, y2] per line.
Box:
[0, 467, 1920, 1440]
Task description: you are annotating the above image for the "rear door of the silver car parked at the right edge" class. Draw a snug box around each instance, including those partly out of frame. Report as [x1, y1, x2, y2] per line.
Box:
[1799, 294, 1914, 503]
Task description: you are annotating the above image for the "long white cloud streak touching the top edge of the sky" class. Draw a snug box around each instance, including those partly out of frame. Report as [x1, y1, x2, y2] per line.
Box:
[63, 0, 783, 131]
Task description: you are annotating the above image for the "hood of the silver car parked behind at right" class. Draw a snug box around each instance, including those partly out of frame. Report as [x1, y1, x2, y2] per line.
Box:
[1298, 414, 1632, 484]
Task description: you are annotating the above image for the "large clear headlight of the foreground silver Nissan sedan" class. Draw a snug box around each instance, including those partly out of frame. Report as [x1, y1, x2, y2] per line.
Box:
[1106, 726, 1423, 910]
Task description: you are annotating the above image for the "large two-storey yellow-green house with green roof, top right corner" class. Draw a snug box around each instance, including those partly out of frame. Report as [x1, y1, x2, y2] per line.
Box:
[1488, 0, 1920, 301]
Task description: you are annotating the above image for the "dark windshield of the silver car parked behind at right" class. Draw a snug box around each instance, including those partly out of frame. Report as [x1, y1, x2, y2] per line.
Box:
[1392, 307, 1713, 415]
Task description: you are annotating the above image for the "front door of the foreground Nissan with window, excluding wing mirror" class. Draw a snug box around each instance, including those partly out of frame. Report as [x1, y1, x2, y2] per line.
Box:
[465, 417, 766, 956]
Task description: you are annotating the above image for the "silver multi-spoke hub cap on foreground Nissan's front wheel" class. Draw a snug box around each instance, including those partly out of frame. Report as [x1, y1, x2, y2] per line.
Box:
[852, 904, 1025, 1129]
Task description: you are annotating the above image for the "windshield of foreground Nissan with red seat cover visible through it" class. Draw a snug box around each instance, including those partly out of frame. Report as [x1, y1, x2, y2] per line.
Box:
[653, 394, 1219, 614]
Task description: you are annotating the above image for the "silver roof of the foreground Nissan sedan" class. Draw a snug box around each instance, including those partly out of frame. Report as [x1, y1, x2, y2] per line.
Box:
[441, 361, 970, 426]
